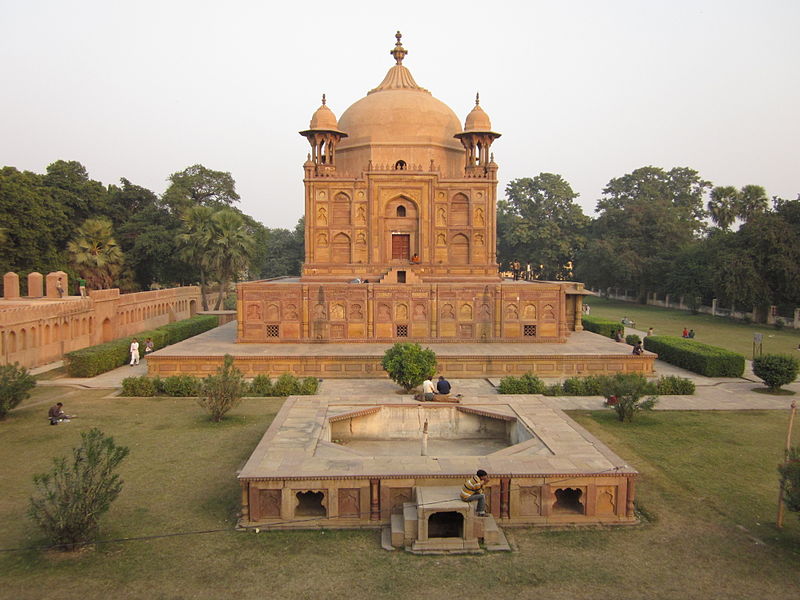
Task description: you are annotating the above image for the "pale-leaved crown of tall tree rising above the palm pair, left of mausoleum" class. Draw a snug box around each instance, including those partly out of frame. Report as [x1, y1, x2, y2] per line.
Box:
[163, 165, 239, 214]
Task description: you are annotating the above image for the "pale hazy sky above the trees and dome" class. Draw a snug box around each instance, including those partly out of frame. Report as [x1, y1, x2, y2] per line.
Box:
[0, 0, 800, 228]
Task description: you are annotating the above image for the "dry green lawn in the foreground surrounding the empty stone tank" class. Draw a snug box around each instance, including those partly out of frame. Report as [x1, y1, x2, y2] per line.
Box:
[0, 388, 800, 600]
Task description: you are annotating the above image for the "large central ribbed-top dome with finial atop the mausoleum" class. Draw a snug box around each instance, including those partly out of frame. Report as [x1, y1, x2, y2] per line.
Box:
[318, 31, 488, 176]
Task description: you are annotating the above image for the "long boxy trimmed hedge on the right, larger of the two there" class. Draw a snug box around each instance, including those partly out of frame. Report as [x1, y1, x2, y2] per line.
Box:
[644, 335, 744, 377]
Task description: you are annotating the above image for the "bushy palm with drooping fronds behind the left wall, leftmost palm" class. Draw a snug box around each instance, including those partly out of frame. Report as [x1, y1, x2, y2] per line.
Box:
[67, 217, 123, 289]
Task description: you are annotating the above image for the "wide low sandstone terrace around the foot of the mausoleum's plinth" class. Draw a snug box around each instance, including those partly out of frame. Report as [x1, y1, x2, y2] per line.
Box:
[147, 323, 657, 378]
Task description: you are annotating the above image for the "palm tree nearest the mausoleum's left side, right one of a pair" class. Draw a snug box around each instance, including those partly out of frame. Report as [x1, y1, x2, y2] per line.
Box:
[209, 208, 255, 310]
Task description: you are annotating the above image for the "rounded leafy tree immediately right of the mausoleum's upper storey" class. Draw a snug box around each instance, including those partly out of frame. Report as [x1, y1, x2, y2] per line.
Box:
[497, 173, 590, 280]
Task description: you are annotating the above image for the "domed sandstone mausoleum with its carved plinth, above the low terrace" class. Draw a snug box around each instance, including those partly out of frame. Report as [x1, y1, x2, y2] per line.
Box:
[237, 34, 585, 343]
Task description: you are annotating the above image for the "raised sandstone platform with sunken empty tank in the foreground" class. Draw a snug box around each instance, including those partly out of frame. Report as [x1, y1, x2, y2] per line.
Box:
[239, 395, 638, 528]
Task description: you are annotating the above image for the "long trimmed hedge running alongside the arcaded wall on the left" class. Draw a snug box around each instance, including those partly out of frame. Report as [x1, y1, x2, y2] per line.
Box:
[64, 315, 219, 377]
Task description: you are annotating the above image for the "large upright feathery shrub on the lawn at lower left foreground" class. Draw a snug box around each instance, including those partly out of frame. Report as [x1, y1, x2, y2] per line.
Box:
[28, 428, 129, 550]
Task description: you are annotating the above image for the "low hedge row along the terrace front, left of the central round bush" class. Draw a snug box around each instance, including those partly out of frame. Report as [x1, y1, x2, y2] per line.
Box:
[122, 373, 319, 397]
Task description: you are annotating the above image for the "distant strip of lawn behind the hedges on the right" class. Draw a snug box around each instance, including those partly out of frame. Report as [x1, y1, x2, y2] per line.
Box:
[586, 296, 800, 359]
